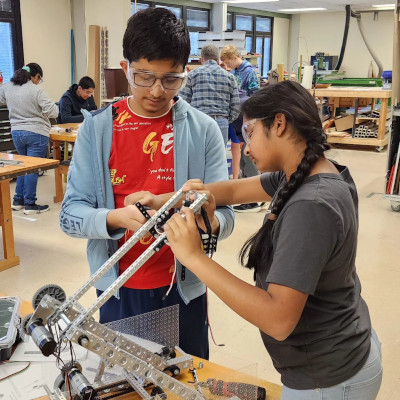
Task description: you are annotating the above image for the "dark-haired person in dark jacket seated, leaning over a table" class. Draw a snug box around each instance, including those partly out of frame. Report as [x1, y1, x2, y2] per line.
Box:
[57, 76, 97, 124]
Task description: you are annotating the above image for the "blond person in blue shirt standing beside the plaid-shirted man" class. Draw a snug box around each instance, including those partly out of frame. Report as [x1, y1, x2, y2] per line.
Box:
[220, 45, 261, 213]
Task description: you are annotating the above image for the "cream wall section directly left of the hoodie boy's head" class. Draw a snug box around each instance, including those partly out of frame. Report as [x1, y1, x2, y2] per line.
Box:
[85, 0, 131, 68]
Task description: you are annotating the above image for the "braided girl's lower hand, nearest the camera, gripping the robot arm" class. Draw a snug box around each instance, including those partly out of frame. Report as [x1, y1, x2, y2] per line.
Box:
[164, 207, 206, 269]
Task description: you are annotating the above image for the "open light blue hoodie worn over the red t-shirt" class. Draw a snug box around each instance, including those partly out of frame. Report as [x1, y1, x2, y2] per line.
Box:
[60, 97, 234, 304]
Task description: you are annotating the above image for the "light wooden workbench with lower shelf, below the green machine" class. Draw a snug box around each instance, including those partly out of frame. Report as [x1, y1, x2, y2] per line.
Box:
[309, 86, 392, 151]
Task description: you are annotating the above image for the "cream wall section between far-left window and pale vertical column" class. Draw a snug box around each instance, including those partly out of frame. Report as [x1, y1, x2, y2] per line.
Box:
[21, 0, 71, 101]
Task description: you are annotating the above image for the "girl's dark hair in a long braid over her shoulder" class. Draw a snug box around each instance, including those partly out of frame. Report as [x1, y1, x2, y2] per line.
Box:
[239, 81, 329, 271]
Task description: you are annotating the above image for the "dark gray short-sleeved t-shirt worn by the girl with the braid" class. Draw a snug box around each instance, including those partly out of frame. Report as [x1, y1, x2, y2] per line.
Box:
[256, 165, 371, 390]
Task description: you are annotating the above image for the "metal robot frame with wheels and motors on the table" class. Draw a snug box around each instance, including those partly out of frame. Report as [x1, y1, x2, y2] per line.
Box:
[22, 189, 228, 400]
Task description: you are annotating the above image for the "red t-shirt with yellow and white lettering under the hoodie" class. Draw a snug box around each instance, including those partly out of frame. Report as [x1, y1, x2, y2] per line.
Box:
[108, 99, 175, 289]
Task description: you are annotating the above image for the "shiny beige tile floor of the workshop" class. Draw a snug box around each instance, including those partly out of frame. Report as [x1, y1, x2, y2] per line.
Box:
[0, 149, 400, 400]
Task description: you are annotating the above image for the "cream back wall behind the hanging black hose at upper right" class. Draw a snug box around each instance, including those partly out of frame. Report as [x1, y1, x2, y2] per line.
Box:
[298, 11, 394, 77]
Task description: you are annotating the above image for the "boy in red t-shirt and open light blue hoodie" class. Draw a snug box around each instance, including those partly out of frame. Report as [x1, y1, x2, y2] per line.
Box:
[60, 8, 234, 358]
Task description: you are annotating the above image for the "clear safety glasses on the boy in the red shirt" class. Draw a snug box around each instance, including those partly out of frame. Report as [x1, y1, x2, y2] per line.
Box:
[128, 63, 187, 90]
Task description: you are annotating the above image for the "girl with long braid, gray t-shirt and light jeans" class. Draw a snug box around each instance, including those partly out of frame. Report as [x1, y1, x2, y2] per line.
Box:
[165, 81, 382, 400]
